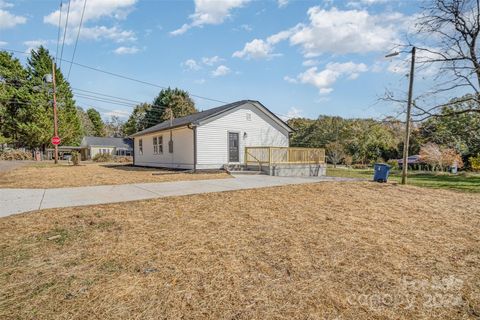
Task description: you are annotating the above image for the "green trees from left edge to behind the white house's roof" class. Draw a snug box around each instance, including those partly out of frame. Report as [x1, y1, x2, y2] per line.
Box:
[0, 46, 197, 150]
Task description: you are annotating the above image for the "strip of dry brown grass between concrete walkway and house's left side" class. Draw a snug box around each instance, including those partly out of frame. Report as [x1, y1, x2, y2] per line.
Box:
[0, 163, 229, 188]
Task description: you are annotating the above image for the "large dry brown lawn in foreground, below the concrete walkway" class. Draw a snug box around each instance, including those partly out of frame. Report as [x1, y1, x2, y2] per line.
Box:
[0, 182, 480, 319]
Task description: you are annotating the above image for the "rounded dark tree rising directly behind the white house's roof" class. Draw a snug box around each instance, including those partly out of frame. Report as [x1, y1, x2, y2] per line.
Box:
[145, 88, 197, 127]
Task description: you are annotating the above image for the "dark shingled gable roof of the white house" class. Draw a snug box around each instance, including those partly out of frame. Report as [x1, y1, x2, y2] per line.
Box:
[131, 100, 290, 137]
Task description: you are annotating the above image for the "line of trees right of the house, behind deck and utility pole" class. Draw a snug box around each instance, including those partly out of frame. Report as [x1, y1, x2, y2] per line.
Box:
[288, 97, 480, 169]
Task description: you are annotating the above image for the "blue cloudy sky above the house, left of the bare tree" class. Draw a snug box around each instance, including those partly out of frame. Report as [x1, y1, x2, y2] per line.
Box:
[0, 0, 428, 119]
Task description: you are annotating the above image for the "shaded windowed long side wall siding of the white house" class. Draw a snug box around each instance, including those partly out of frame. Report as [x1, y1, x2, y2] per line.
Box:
[134, 127, 193, 169]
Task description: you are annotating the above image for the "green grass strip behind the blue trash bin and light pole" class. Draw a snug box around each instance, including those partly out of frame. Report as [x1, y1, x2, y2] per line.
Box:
[327, 167, 480, 193]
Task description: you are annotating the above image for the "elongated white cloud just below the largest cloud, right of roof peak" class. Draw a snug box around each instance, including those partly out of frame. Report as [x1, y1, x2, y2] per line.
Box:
[284, 61, 368, 94]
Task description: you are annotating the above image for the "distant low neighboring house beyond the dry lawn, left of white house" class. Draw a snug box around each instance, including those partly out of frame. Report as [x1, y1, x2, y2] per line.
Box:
[80, 137, 133, 160]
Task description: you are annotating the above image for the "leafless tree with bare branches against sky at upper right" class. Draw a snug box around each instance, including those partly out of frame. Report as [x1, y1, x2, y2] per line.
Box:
[382, 0, 480, 121]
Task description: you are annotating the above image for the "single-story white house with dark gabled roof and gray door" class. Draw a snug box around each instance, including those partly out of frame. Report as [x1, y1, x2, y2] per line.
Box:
[131, 100, 293, 169]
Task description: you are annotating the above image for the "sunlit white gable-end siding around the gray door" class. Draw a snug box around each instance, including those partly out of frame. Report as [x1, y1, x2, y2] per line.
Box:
[197, 104, 289, 169]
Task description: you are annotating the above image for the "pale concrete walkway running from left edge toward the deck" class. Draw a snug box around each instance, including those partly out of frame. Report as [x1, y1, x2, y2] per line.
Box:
[0, 175, 351, 217]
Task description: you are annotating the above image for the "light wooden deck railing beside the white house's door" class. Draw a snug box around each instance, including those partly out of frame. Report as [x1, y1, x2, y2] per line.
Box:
[245, 147, 325, 166]
